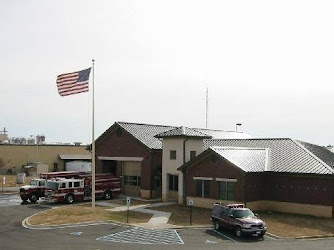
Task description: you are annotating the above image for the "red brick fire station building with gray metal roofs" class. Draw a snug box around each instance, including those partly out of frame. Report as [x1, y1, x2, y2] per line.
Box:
[95, 122, 334, 217]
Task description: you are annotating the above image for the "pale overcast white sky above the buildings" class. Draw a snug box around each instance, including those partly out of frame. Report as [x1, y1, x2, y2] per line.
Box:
[0, 0, 334, 145]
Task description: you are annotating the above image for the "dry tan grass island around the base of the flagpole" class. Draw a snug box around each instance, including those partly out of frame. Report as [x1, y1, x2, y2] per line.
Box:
[29, 204, 152, 225]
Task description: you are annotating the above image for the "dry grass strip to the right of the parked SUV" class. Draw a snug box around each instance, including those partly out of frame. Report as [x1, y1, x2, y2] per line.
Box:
[258, 212, 334, 237]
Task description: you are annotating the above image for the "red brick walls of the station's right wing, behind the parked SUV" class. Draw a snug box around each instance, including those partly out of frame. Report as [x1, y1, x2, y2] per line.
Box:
[187, 153, 334, 206]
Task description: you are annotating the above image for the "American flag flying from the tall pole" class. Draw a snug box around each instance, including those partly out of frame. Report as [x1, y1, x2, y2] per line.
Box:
[57, 68, 91, 96]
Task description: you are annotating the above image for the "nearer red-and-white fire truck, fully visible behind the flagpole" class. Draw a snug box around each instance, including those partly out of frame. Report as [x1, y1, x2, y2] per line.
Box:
[45, 174, 121, 204]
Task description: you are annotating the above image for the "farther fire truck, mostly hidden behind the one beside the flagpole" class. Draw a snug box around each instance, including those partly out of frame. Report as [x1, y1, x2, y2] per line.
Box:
[20, 171, 86, 202]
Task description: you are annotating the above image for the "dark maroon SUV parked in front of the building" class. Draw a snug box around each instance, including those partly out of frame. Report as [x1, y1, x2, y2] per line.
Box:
[211, 204, 267, 237]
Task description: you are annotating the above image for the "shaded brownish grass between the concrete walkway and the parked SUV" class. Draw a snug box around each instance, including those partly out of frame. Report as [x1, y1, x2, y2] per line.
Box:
[150, 204, 212, 226]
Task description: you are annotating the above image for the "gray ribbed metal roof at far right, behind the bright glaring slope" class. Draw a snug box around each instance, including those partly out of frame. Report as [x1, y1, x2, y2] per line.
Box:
[204, 138, 334, 174]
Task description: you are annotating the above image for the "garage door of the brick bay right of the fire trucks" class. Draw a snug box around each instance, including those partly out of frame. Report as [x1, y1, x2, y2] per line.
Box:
[123, 161, 141, 196]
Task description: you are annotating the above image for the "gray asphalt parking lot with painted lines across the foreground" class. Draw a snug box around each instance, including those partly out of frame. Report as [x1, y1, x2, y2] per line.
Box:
[0, 195, 334, 250]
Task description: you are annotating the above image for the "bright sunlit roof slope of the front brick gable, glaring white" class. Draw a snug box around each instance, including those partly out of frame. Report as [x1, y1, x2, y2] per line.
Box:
[210, 147, 269, 172]
